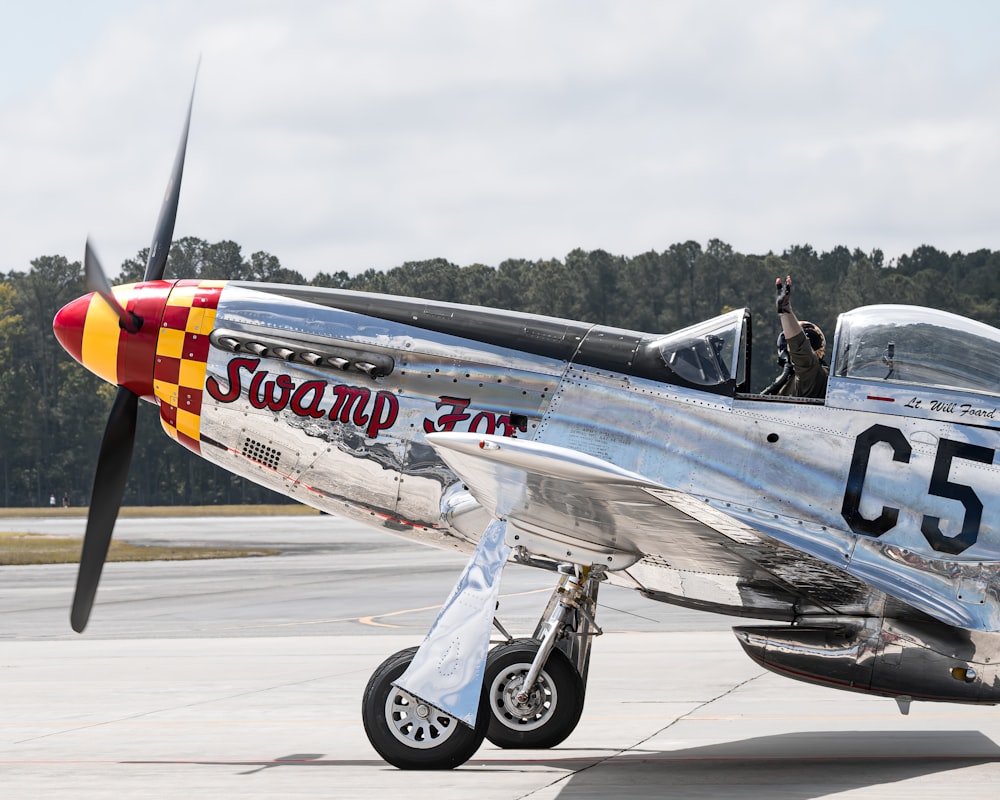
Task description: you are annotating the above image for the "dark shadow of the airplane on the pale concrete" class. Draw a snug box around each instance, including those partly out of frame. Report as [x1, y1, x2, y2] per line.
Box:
[122, 730, 1000, 800]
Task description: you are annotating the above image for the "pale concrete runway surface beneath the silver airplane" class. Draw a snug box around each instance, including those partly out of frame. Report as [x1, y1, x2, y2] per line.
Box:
[0, 516, 1000, 800]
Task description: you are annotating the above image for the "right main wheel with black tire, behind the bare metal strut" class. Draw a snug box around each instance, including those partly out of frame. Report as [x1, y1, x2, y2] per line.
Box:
[483, 639, 584, 749]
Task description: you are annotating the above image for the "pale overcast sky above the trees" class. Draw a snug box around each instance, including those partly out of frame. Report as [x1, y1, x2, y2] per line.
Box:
[0, 0, 1000, 277]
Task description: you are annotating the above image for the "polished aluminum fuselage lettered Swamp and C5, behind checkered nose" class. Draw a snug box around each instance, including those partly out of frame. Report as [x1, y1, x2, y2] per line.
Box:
[191, 284, 1000, 702]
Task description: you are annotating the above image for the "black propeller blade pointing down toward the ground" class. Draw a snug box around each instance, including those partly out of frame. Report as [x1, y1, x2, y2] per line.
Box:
[70, 386, 139, 633]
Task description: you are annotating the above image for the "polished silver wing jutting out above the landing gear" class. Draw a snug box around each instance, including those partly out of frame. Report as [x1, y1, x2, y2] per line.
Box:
[427, 433, 886, 619]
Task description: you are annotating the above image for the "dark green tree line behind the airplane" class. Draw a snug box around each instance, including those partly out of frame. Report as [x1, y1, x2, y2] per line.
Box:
[0, 237, 1000, 507]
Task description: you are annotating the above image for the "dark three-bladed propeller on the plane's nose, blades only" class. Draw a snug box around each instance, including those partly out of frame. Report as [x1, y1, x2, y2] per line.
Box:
[70, 71, 197, 633]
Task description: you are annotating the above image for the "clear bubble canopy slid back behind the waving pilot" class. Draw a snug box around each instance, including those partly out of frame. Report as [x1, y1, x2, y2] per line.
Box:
[833, 305, 1000, 394]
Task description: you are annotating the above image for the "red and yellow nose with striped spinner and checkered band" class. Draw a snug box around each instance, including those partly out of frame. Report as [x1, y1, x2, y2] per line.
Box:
[52, 281, 225, 452]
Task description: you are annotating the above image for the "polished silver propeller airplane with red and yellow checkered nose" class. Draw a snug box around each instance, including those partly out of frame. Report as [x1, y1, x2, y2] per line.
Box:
[53, 81, 1000, 769]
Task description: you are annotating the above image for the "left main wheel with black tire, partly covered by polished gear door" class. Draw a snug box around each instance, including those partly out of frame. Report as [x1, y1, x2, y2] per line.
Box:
[361, 647, 488, 769]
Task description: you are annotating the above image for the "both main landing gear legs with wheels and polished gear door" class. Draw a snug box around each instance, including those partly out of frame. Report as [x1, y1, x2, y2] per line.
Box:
[362, 556, 604, 769]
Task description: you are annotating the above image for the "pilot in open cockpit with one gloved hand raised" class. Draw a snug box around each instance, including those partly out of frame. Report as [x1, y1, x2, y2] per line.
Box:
[764, 276, 829, 397]
